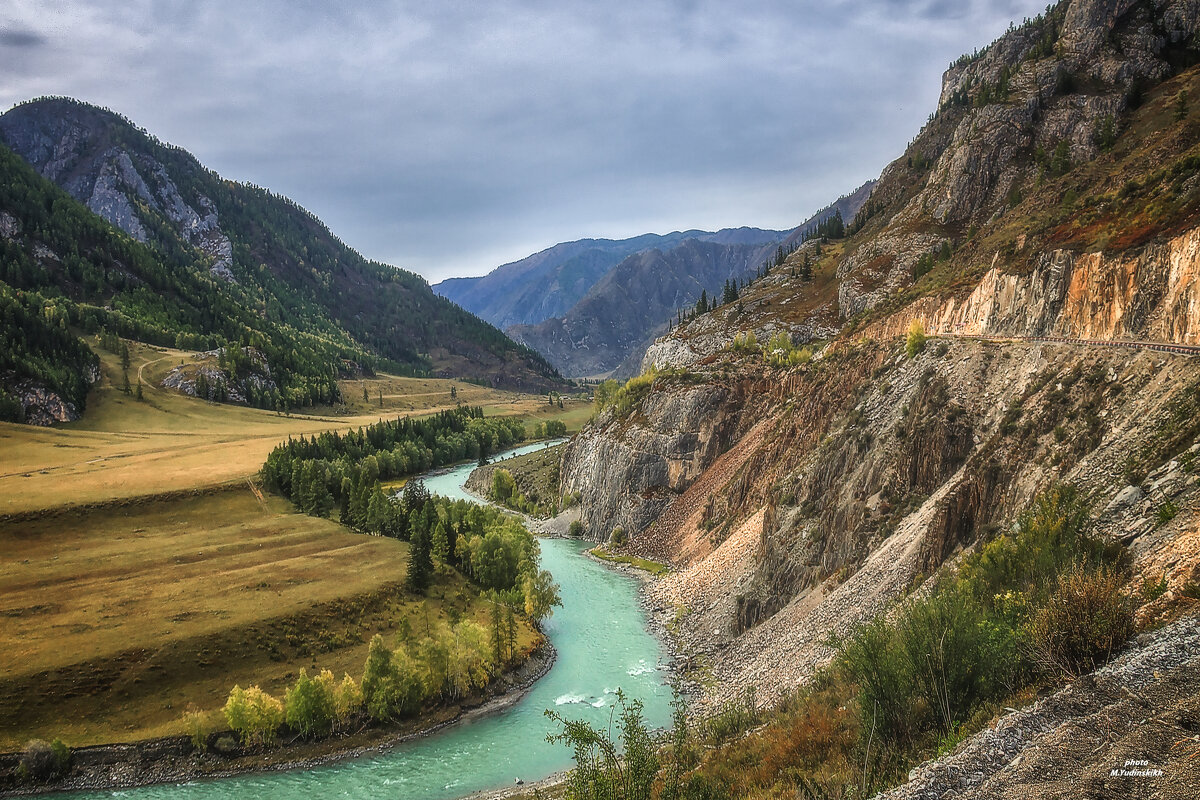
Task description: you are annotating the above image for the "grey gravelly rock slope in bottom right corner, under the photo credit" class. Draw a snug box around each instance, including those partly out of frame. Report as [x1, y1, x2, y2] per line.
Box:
[880, 616, 1200, 800]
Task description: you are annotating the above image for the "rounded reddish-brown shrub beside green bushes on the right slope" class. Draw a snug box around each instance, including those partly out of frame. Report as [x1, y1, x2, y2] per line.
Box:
[1030, 566, 1134, 676]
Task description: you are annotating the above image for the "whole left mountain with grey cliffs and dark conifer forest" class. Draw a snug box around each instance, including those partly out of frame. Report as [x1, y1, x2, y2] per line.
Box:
[0, 98, 559, 419]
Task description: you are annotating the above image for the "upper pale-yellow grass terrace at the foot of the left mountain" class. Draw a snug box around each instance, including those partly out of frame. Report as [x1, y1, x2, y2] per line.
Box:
[0, 342, 586, 515]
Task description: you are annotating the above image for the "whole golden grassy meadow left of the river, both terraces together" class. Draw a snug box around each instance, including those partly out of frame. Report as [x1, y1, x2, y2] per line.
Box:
[0, 342, 580, 751]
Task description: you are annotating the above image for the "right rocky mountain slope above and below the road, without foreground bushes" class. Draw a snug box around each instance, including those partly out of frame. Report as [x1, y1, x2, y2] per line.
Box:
[562, 0, 1200, 796]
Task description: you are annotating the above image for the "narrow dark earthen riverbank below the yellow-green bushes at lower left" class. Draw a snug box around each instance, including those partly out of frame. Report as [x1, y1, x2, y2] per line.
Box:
[0, 639, 558, 796]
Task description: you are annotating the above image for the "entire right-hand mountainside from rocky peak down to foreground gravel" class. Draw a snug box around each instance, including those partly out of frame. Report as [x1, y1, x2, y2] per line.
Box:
[559, 0, 1200, 799]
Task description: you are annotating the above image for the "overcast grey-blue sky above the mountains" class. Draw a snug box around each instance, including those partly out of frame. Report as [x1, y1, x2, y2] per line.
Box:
[0, 0, 1045, 282]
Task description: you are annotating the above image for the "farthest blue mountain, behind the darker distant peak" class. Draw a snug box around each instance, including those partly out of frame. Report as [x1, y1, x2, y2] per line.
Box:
[433, 228, 786, 329]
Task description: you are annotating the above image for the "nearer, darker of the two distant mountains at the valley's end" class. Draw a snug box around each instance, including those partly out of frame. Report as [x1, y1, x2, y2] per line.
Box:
[506, 181, 875, 378]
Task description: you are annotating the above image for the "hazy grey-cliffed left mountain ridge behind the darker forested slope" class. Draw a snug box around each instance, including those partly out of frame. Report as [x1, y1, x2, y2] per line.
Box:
[0, 97, 560, 419]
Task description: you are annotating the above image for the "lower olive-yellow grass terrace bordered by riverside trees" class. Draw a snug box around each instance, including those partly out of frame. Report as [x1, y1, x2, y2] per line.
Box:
[0, 488, 534, 751]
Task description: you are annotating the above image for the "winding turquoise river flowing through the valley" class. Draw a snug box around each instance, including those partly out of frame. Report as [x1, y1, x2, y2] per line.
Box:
[60, 445, 671, 800]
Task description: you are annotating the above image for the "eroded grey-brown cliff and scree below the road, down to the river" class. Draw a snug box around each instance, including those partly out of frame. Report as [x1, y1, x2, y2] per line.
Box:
[563, 339, 1200, 702]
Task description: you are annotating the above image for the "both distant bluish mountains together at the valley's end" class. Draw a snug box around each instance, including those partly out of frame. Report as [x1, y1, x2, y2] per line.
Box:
[433, 181, 874, 378]
